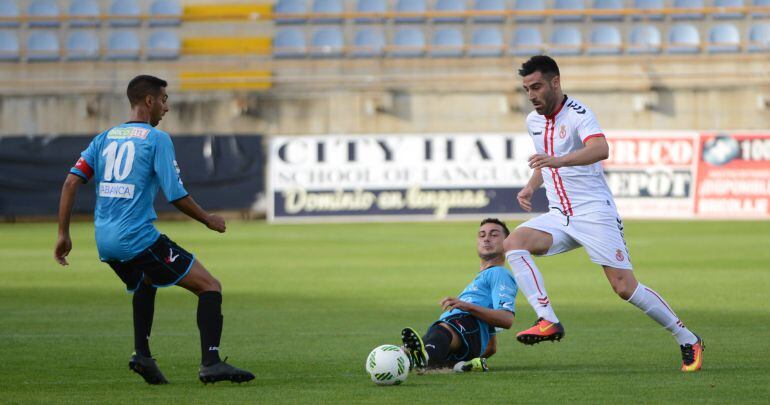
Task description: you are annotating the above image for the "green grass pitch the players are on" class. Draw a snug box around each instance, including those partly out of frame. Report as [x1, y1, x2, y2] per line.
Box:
[0, 221, 770, 404]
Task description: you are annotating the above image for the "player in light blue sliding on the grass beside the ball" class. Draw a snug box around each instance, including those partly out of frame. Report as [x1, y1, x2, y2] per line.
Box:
[401, 218, 518, 371]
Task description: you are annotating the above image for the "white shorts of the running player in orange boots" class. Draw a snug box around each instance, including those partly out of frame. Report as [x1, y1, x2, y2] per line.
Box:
[516, 210, 633, 270]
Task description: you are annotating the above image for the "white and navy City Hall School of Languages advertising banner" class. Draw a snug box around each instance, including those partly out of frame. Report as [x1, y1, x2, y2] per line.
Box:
[268, 134, 547, 221]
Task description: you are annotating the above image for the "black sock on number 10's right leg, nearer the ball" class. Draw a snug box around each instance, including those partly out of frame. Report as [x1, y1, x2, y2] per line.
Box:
[198, 291, 223, 366]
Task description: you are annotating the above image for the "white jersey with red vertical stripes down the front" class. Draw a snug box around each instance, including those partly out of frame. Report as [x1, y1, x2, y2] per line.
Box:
[527, 96, 615, 216]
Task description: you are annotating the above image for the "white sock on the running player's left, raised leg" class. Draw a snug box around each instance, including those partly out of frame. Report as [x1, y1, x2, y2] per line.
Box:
[505, 250, 559, 323]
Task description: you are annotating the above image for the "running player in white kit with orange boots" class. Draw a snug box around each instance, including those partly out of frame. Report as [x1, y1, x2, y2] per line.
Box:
[504, 55, 705, 372]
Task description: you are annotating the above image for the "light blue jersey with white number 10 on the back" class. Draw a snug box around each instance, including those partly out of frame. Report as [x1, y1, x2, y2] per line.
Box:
[70, 122, 188, 261]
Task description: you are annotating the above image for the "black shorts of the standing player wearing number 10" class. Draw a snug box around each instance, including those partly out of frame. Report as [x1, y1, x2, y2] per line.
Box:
[107, 235, 195, 292]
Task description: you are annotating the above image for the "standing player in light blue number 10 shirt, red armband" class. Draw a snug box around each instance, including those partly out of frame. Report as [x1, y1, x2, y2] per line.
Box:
[54, 75, 254, 384]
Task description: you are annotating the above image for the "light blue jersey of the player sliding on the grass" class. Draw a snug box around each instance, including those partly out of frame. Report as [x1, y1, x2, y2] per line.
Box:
[439, 266, 519, 353]
